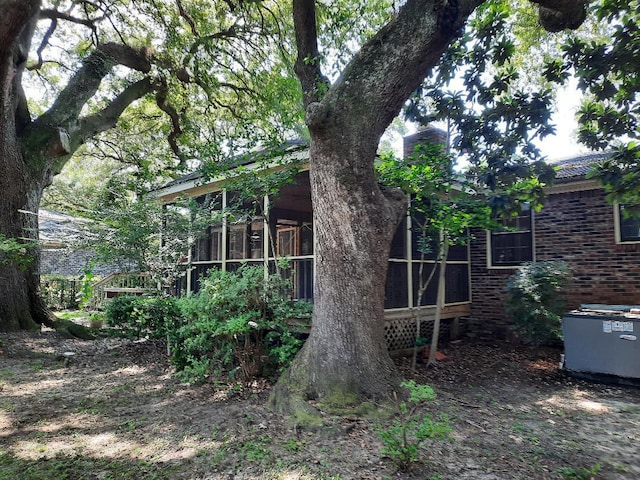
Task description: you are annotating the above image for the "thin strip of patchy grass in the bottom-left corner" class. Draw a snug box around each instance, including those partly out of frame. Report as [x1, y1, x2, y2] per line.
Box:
[0, 453, 176, 480]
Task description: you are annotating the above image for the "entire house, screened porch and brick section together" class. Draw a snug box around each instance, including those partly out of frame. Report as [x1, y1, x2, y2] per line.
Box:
[156, 135, 640, 344]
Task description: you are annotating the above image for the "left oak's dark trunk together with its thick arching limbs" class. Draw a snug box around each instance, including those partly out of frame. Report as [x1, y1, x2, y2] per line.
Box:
[0, 0, 153, 331]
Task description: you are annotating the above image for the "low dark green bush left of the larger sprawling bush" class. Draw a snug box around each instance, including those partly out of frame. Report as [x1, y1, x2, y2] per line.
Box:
[105, 295, 181, 339]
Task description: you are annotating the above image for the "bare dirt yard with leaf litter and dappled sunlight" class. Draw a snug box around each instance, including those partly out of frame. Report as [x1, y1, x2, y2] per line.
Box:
[0, 332, 640, 480]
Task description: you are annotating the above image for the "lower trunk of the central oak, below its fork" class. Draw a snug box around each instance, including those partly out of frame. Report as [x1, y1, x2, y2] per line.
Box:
[276, 135, 405, 402]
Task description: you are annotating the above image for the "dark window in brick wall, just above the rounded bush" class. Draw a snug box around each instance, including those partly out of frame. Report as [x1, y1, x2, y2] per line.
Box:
[489, 206, 533, 267]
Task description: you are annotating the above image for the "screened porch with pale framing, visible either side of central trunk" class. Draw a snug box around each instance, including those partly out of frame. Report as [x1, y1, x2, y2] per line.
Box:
[156, 133, 471, 352]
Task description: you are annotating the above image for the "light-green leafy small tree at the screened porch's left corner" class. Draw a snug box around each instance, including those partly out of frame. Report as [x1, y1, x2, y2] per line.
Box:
[60, 170, 220, 287]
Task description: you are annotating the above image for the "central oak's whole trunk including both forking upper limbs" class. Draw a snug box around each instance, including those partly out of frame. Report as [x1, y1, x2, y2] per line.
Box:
[272, 0, 580, 404]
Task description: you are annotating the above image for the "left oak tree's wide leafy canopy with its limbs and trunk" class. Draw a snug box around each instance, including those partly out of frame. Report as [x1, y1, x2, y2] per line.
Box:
[0, 0, 300, 329]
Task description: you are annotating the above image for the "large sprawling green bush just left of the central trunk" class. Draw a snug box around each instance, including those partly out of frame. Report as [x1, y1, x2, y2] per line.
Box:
[169, 266, 311, 382]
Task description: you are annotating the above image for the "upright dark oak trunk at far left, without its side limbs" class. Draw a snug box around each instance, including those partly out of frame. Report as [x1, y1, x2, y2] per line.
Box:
[0, 0, 49, 330]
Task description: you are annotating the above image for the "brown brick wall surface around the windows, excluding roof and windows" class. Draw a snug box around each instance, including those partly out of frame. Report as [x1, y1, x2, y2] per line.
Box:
[470, 190, 640, 335]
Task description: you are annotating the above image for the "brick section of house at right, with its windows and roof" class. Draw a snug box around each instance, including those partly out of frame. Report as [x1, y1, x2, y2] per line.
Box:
[471, 153, 640, 336]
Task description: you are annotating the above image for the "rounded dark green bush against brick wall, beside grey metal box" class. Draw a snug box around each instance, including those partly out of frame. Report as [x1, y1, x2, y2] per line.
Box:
[506, 261, 571, 347]
